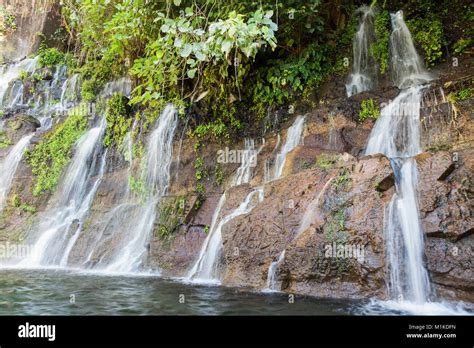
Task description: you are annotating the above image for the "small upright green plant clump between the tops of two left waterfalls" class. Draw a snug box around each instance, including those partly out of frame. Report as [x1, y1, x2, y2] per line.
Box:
[104, 93, 132, 147]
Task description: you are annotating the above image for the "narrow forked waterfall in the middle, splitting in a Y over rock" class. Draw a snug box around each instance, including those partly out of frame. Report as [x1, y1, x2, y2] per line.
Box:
[186, 139, 263, 283]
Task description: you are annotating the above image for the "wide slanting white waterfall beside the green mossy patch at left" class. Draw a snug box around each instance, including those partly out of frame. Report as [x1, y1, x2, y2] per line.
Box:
[20, 120, 106, 267]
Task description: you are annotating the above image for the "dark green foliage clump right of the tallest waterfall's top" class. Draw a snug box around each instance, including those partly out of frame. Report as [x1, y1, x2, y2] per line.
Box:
[407, 16, 444, 66]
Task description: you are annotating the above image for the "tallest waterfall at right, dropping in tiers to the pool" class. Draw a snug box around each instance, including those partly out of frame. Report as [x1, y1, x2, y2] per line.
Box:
[366, 11, 436, 304]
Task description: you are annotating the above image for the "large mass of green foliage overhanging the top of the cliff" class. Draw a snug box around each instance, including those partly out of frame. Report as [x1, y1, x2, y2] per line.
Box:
[63, 0, 342, 141]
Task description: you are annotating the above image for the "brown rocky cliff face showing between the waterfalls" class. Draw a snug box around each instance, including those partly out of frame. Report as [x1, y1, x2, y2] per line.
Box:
[0, 47, 474, 302]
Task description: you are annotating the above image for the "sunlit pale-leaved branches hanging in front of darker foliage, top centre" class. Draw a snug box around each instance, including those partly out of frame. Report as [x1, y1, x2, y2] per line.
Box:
[131, 7, 276, 107]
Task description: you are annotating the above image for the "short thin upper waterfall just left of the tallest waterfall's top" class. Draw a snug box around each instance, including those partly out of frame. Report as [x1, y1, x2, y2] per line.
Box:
[346, 6, 378, 97]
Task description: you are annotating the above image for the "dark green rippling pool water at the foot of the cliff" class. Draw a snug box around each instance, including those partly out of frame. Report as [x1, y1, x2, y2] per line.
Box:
[0, 270, 356, 315]
